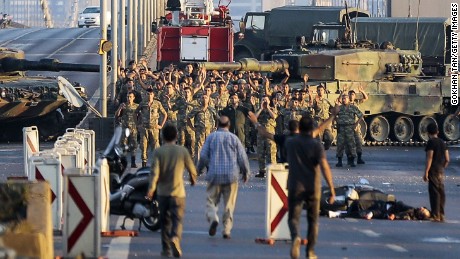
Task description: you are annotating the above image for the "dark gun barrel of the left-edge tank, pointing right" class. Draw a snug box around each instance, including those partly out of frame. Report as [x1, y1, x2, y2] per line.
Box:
[0, 57, 99, 72]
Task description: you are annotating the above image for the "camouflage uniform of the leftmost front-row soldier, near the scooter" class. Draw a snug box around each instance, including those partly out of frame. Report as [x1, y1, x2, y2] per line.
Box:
[121, 103, 139, 159]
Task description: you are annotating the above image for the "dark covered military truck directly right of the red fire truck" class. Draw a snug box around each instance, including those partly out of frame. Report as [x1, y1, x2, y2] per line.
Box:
[233, 6, 370, 60]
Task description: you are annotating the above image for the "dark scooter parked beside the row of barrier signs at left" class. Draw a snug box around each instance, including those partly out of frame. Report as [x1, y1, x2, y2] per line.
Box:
[98, 127, 160, 231]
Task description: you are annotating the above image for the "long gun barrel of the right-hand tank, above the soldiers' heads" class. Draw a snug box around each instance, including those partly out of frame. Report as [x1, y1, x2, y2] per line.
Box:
[196, 58, 289, 73]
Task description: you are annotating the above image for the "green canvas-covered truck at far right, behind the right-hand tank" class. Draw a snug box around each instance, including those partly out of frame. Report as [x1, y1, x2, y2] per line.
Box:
[307, 17, 451, 76]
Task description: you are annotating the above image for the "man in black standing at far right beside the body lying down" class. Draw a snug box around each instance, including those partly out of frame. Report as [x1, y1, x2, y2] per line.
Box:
[423, 123, 449, 222]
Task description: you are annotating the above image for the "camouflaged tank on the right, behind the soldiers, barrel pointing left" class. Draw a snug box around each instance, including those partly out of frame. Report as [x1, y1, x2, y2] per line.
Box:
[195, 48, 460, 145]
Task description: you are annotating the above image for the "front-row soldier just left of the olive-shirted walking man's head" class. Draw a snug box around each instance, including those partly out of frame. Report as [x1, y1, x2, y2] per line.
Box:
[136, 89, 168, 167]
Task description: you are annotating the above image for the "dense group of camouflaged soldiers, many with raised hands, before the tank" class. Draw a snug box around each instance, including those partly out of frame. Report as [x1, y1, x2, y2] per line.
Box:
[115, 60, 367, 177]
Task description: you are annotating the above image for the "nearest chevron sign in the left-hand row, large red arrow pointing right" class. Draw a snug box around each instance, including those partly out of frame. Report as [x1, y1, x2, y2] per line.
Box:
[63, 174, 101, 258]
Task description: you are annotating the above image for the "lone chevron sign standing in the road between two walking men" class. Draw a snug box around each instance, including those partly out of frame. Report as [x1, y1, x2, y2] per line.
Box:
[265, 164, 291, 240]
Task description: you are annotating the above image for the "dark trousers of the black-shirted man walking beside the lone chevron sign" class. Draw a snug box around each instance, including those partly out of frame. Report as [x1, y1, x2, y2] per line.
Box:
[288, 192, 321, 256]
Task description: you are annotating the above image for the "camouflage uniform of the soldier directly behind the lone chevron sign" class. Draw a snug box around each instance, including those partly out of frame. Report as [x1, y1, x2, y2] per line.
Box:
[257, 108, 278, 171]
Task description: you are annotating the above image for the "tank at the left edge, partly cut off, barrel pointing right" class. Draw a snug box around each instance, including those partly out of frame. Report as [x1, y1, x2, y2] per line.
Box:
[0, 48, 99, 141]
